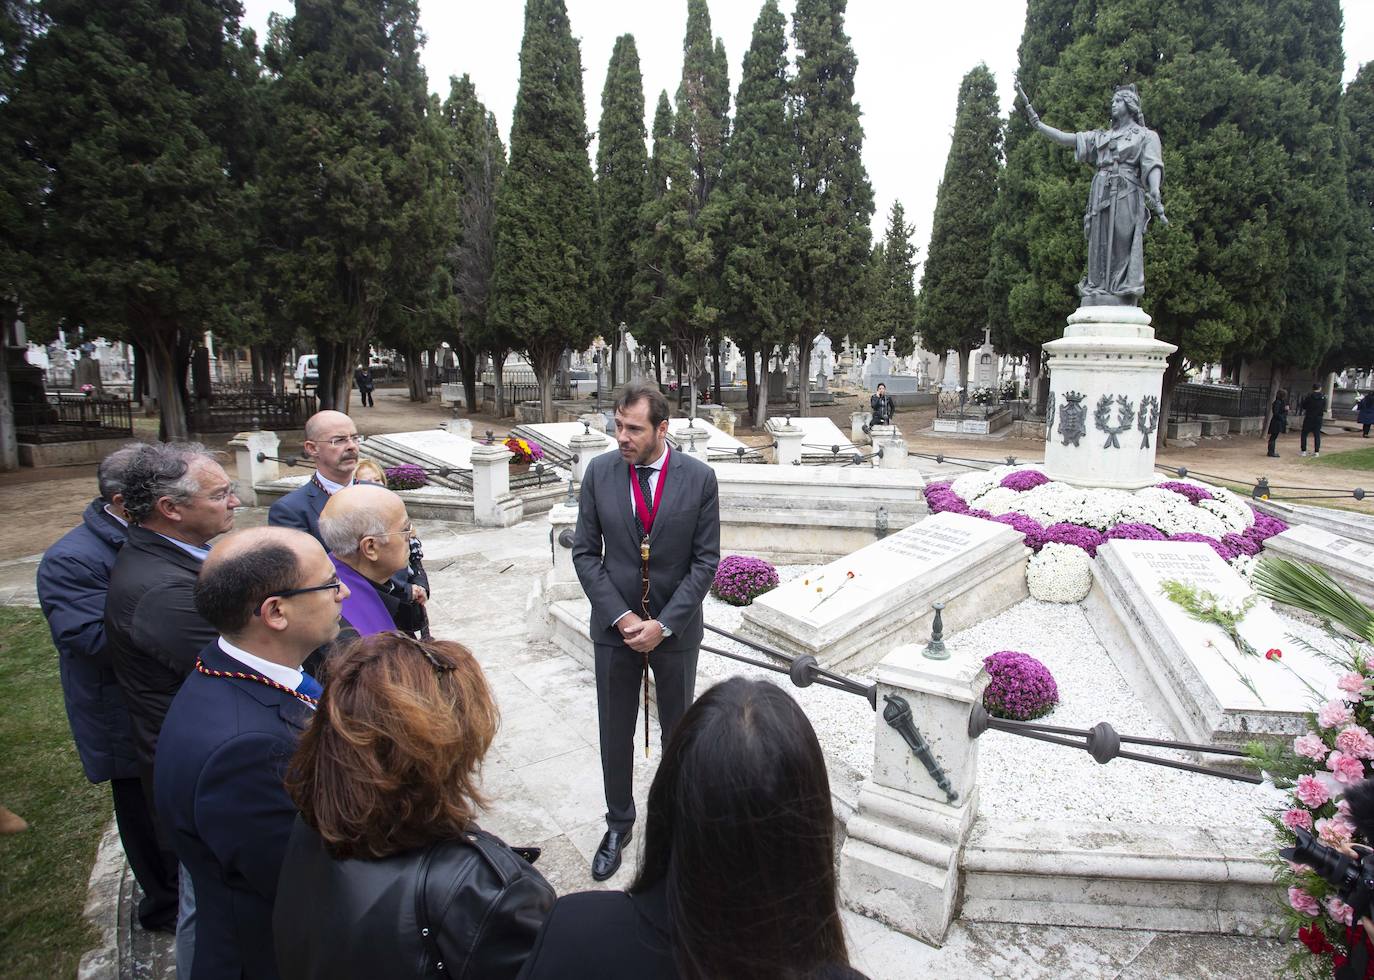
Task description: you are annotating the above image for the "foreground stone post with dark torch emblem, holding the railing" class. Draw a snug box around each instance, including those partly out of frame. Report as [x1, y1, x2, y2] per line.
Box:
[840, 646, 988, 946]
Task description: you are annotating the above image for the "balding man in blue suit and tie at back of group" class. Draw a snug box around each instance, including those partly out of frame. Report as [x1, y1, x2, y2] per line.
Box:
[267, 411, 429, 605]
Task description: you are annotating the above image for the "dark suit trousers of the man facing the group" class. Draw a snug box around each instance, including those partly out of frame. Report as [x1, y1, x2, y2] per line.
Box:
[595, 643, 699, 832]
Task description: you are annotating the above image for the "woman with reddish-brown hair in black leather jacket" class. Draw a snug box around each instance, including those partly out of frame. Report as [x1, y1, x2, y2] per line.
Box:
[272, 632, 554, 980]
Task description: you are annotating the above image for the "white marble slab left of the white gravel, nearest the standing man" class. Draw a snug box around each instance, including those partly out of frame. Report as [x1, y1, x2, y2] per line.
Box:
[743, 513, 1026, 668]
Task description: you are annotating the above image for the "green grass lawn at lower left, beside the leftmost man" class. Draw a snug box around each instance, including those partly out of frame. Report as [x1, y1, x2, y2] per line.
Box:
[0, 608, 113, 977]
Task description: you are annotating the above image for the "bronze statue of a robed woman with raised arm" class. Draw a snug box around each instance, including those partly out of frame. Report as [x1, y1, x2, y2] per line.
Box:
[1017, 85, 1169, 307]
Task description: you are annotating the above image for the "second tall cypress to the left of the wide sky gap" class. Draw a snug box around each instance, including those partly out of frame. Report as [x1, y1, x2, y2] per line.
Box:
[708, 0, 796, 426]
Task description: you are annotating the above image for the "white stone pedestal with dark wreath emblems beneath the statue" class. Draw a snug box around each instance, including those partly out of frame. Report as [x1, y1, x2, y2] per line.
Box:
[1044, 307, 1178, 489]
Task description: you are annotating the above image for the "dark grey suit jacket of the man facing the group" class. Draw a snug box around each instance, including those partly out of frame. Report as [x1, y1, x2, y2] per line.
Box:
[573, 451, 720, 652]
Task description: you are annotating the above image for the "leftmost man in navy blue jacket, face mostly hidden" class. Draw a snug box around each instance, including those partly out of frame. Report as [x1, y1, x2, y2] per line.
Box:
[38, 445, 177, 932]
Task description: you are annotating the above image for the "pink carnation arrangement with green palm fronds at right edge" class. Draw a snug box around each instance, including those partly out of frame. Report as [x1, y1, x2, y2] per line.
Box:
[1246, 558, 1374, 977]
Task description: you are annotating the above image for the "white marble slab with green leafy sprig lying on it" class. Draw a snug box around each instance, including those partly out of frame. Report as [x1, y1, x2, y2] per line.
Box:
[1088, 540, 1336, 745]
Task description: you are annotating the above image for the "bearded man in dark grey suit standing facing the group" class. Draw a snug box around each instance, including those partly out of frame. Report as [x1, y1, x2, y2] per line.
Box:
[573, 382, 720, 881]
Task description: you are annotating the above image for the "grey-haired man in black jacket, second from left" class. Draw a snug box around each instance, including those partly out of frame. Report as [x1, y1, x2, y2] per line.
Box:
[104, 443, 239, 969]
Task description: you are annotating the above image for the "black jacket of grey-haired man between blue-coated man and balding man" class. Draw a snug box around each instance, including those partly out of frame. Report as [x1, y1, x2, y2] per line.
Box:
[104, 525, 217, 789]
